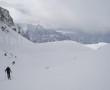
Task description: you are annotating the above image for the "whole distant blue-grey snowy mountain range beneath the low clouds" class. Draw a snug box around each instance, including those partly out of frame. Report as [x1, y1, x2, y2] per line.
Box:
[17, 24, 110, 44]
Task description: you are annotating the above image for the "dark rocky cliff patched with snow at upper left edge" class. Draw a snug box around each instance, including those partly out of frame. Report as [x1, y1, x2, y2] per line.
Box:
[0, 7, 14, 27]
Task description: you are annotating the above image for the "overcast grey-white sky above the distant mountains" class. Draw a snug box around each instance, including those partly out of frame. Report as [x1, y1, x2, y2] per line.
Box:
[0, 0, 110, 30]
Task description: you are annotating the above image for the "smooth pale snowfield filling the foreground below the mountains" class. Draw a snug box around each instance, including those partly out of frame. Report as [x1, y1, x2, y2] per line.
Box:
[0, 25, 110, 90]
